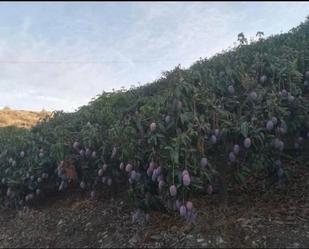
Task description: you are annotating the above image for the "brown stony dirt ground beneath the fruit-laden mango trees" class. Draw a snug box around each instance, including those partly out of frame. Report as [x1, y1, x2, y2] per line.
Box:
[0, 161, 309, 248]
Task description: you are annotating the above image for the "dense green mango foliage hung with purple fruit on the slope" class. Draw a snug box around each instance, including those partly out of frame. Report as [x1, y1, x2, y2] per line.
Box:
[0, 20, 309, 223]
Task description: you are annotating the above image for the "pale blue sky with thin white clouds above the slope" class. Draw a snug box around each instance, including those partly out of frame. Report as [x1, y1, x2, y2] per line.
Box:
[0, 2, 309, 112]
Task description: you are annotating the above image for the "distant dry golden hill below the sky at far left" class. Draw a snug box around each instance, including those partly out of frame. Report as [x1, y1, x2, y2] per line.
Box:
[0, 108, 51, 128]
